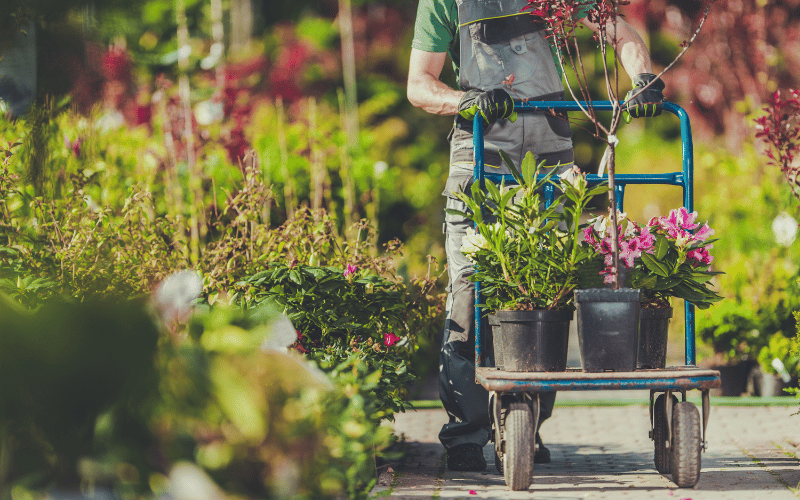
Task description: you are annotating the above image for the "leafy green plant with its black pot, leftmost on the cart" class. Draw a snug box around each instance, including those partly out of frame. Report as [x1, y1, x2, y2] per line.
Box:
[448, 151, 608, 371]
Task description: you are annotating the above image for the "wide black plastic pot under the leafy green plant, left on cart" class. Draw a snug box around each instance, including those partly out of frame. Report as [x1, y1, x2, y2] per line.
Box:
[495, 310, 573, 372]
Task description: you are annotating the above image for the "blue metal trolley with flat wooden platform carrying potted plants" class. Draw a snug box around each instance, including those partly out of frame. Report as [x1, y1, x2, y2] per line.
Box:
[473, 101, 720, 490]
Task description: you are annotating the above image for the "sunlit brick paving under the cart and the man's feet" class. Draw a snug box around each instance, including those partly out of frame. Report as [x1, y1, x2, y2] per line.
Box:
[371, 404, 800, 500]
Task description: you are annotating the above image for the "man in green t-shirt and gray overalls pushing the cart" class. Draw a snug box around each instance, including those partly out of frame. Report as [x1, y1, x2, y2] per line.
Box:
[408, 0, 664, 471]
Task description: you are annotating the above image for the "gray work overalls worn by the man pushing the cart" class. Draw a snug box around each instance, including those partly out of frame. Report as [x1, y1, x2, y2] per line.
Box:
[439, 0, 573, 448]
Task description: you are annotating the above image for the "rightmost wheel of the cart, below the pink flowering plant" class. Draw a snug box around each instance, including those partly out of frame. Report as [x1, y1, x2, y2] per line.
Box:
[670, 401, 700, 488]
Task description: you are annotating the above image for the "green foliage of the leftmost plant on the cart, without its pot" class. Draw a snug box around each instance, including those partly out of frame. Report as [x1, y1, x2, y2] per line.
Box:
[448, 153, 607, 311]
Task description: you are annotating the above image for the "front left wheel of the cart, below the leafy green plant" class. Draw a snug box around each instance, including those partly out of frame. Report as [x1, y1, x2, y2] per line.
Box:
[503, 403, 533, 491]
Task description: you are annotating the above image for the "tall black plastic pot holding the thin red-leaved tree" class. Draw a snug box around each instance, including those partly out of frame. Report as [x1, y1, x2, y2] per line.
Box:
[575, 288, 642, 372]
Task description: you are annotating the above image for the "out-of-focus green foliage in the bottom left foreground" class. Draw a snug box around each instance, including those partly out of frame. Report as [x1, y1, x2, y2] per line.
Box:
[0, 294, 393, 499]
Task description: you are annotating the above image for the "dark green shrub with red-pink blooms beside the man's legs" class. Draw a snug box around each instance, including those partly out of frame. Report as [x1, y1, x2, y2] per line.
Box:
[238, 264, 419, 418]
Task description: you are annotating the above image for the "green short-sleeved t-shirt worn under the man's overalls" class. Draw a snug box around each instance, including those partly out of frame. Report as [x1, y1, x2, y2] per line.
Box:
[411, 0, 589, 84]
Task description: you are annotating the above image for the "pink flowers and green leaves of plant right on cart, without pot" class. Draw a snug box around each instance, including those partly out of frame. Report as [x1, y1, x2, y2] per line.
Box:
[583, 207, 722, 309]
